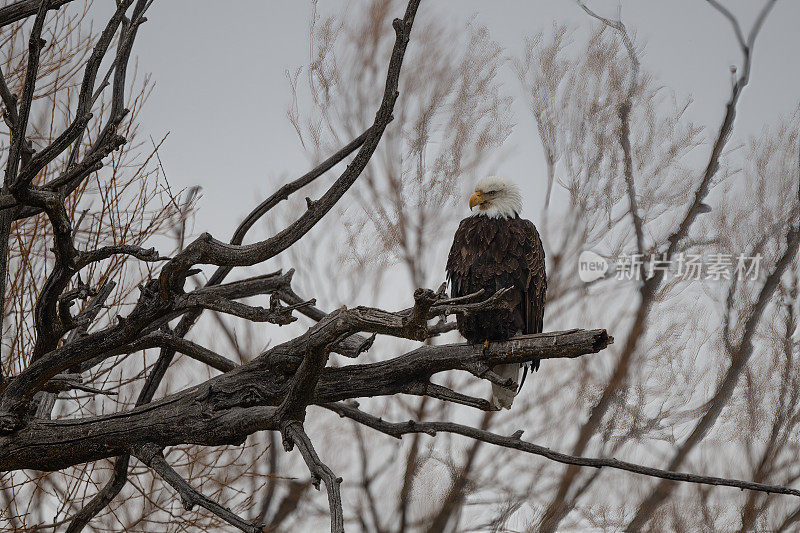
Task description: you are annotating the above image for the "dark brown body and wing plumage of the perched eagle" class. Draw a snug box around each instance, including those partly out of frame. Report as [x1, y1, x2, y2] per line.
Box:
[447, 215, 547, 370]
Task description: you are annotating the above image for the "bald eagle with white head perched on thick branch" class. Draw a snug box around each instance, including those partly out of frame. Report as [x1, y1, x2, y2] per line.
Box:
[447, 176, 547, 409]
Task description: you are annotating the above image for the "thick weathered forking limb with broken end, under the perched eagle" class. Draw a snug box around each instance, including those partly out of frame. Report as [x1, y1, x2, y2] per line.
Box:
[0, 324, 612, 471]
